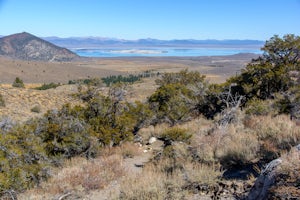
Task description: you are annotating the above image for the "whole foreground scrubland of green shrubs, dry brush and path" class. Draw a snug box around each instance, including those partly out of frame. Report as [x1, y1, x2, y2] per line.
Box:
[0, 35, 300, 200]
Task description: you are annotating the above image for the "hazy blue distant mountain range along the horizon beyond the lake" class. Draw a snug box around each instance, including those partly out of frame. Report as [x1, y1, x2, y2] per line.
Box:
[43, 37, 264, 48]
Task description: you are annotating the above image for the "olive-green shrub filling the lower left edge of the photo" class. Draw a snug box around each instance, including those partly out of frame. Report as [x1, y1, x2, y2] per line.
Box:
[0, 125, 49, 192]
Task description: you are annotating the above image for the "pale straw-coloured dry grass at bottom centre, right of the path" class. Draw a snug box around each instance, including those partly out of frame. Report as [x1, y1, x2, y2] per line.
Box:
[115, 159, 222, 200]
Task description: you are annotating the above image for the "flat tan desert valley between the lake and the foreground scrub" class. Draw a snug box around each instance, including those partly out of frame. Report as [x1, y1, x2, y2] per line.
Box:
[0, 54, 257, 84]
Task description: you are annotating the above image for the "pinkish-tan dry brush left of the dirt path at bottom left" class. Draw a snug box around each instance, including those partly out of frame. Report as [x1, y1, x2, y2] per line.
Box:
[20, 155, 125, 199]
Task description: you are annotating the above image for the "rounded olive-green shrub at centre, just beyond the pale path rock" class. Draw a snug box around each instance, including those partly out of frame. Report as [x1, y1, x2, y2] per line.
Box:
[148, 70, 207, 125]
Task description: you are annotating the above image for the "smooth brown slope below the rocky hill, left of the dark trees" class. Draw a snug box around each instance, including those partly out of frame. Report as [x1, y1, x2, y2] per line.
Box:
[0, 57, 123, 85]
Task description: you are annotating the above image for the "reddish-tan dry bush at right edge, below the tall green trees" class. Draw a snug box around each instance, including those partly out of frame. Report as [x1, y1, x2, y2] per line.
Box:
[244, 115, 300, 151]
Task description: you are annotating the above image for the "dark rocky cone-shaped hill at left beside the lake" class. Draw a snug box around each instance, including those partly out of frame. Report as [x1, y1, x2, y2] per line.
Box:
[0, 32, 78, 61]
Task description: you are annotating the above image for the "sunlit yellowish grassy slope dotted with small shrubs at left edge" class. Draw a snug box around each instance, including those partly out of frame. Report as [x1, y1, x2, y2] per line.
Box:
[0, 85, 81, 122]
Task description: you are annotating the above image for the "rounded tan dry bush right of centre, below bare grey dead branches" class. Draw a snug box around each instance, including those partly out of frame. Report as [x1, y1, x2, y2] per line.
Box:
[191, 124, 259, 167]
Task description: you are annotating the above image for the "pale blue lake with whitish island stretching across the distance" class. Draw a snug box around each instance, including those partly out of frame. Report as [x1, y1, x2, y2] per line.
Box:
[71, 48, 262, 57]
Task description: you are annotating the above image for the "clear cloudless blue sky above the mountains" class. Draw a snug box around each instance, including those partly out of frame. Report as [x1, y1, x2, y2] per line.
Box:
[0, 0, 300, 40]
